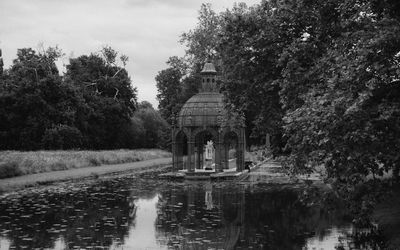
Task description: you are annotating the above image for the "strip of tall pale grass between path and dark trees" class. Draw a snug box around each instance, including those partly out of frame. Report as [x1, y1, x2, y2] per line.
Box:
[0, 149, 171, 179]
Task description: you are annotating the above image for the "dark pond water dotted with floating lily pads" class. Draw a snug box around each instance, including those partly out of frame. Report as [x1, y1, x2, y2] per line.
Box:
[0, 177, 376, 250]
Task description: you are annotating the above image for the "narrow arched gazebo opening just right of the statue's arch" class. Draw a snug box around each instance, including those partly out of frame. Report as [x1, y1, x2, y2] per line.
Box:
[223, 131, 241, 169]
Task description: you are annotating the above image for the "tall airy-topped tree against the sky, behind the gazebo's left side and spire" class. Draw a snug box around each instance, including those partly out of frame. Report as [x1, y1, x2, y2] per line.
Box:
[156, 4, 221, 124]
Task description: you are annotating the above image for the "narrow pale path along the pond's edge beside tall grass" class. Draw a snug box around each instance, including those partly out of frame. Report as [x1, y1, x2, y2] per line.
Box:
[0, 157, 172, 191]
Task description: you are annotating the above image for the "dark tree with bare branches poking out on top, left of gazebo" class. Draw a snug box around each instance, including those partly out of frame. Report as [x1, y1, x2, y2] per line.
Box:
[65, 47, 136, 149]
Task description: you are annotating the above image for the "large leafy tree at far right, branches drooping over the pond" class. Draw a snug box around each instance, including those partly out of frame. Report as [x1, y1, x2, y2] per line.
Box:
[281, 0, 400, 223]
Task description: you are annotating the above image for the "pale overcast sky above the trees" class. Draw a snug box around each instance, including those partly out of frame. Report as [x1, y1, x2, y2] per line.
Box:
[0, 0, 261, 108]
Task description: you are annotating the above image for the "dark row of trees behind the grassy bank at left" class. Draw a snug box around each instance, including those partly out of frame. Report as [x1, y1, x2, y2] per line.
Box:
[0, 47, 169, 150]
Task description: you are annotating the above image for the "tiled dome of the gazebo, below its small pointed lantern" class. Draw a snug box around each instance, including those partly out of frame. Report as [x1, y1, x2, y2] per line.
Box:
[178, 92, 227, 127]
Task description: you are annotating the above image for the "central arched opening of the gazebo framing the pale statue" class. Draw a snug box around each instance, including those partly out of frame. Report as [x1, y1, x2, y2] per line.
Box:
[194, 130, 216, 171]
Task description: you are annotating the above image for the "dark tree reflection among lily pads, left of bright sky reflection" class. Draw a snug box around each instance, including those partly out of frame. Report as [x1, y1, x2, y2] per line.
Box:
[0, 182, 134, 249]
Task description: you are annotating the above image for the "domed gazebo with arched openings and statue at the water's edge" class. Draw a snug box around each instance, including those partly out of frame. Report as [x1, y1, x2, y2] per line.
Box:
[172, 63, 245, 173]
